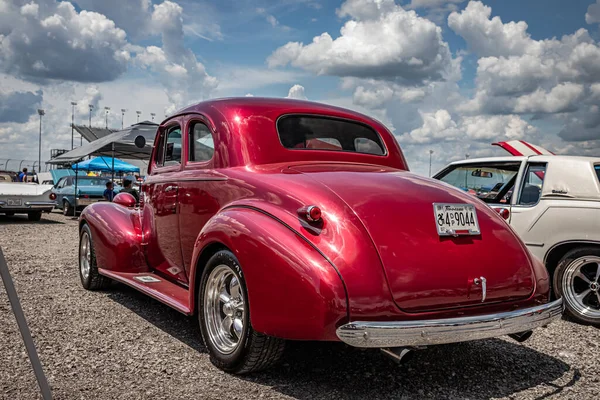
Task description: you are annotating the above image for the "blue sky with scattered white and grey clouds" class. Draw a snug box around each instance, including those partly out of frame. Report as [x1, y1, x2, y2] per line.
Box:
[0, 0, 600, 175]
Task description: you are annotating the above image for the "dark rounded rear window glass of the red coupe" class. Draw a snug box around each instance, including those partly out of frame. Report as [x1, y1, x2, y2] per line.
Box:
[277, 115, 385, 156]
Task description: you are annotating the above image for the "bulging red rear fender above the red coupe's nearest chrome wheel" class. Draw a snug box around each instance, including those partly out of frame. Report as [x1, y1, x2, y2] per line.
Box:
[190, 208, 348, 340]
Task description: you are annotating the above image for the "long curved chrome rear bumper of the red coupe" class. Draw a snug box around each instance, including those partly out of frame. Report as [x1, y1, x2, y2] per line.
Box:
[336, 299, 563, 348]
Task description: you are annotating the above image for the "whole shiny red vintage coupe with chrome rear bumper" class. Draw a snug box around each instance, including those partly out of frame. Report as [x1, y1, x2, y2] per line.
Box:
[79, 98, 562, 374]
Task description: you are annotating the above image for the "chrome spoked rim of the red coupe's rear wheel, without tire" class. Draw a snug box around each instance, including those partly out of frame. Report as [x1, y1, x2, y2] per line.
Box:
[203, 264, 246, 354]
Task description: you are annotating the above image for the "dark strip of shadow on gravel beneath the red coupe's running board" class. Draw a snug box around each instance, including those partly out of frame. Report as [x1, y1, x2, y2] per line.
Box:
[108, 283, 206, 353]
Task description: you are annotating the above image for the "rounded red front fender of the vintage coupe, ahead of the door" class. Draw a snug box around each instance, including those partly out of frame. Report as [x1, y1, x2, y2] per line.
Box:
[80, 202, 148, 273]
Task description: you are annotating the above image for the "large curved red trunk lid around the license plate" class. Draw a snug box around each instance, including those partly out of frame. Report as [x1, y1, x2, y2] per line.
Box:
[292, 164, 535, 312]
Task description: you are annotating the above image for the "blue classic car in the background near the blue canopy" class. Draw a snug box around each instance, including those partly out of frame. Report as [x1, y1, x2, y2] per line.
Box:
[52, 175, 121, 215]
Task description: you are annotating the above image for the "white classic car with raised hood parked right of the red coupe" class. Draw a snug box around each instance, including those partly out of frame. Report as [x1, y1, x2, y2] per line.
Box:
[434, 141, 600, 326]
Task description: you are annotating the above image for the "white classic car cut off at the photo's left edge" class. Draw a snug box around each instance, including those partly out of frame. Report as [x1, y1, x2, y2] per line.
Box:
[0, 181, 56, 221]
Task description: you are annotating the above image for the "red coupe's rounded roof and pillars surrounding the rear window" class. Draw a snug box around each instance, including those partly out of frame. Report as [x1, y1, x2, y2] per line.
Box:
[154, 97, 408, 171]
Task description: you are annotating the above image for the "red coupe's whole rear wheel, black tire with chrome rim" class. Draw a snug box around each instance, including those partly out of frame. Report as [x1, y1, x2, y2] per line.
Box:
[198, 250, 285, 375]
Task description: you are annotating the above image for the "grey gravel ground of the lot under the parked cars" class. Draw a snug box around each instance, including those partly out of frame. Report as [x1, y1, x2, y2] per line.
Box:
[0, 213, 600, 399]
